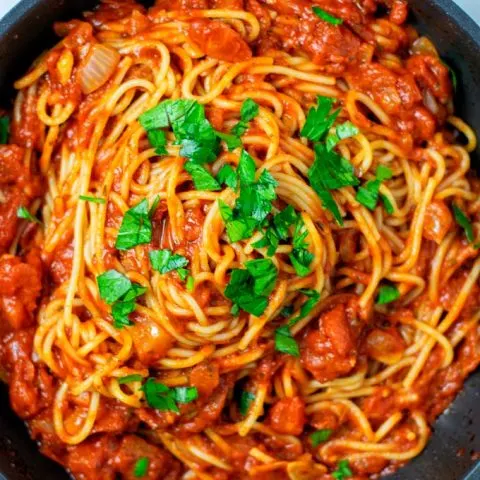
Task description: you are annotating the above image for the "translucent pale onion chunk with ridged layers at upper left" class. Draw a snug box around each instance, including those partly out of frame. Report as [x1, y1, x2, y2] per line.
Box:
[79, 43, 120, 95]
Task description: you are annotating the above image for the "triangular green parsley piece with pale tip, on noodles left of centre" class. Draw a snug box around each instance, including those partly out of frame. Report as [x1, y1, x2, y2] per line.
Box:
[115, 198, 153, 250]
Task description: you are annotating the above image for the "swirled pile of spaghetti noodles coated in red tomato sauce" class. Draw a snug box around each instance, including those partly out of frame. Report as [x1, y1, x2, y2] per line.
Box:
[5, 2, 480, 479]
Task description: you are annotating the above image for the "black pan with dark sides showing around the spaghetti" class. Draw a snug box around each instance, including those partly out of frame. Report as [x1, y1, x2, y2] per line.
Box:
[0, 0, 480, 480]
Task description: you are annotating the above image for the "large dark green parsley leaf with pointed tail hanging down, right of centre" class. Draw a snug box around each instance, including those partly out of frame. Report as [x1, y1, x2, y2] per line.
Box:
[308, 142, 359, 225]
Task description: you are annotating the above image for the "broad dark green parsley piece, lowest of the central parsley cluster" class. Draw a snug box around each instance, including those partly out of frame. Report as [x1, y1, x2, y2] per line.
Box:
[225, 258, 278, 317]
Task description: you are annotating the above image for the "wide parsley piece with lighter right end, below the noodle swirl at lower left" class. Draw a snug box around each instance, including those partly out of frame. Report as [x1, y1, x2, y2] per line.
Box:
[142, 378, 198, 413]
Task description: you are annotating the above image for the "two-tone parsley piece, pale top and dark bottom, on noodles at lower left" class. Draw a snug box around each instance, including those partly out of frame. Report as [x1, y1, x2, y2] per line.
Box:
[97, 270, 147, 329]
